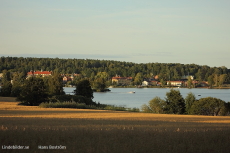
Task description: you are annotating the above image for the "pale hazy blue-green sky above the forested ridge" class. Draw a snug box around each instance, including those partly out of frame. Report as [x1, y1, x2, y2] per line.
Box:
[0, 0, 230, 68]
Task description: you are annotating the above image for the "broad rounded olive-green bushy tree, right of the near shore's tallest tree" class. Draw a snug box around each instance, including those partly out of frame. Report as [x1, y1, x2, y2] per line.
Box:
[191, 97, 225, 116]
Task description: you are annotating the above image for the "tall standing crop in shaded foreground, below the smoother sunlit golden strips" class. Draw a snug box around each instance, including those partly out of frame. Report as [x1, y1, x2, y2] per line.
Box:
[0, 118, 230, 153]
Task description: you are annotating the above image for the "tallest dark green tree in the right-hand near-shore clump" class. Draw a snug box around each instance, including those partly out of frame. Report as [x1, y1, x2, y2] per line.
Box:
[166, 89, 185, 114]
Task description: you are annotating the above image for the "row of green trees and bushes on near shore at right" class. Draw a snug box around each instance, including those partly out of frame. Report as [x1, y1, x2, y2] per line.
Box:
[141, 89, 230, 116]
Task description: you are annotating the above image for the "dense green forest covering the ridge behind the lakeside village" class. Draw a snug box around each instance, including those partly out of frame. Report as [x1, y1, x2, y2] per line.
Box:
[0, 57, 230, 83]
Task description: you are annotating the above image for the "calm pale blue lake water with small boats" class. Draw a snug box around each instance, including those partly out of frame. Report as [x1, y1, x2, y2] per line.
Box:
[64, 88, 230, 108]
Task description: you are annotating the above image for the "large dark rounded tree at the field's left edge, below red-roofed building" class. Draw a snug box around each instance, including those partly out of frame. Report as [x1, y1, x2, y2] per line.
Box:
[17, 77, 48, 106]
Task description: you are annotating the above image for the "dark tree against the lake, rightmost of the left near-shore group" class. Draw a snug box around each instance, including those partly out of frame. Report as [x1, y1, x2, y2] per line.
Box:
[74, 79, 93, 99]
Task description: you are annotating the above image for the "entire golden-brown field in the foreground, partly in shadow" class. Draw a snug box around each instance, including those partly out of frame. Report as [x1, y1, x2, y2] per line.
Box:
[0, 97, 230, 153]
